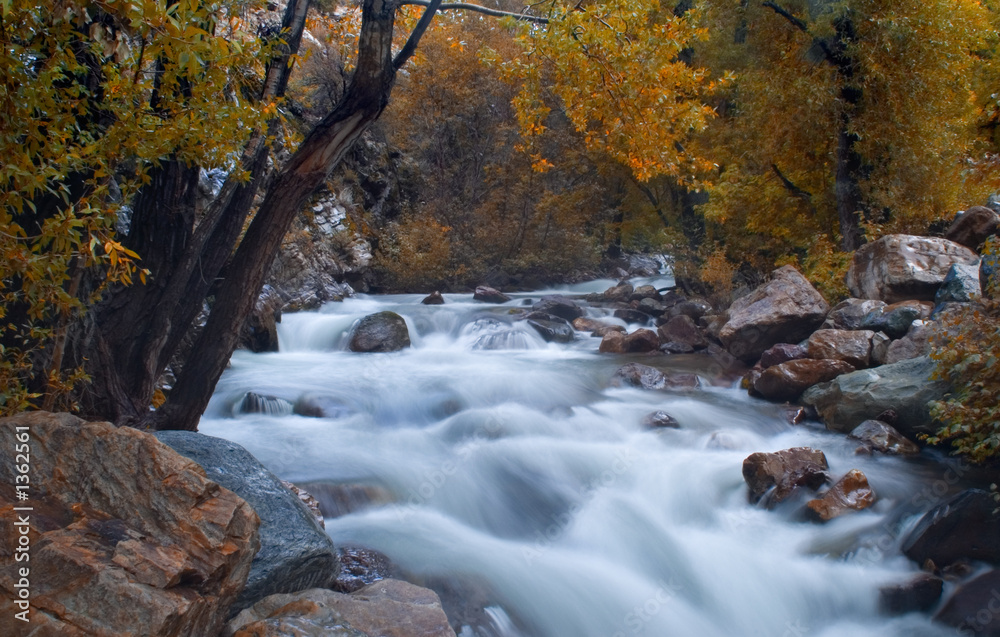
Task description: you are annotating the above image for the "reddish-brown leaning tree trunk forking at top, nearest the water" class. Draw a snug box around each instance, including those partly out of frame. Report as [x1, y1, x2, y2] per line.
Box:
[149, 0, 440, 430]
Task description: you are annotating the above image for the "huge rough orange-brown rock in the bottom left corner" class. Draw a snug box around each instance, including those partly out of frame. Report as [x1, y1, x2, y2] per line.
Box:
[0, 412, 259, 637]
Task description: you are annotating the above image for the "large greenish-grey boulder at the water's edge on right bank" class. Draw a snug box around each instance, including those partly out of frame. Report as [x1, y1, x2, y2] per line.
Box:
[802, 356, 948, 438]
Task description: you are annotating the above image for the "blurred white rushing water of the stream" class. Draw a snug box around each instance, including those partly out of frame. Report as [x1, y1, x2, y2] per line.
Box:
[200, 281, 955, 637]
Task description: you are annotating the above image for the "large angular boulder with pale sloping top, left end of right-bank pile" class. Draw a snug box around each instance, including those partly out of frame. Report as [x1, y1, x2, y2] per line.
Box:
[719, 266, 830, 362]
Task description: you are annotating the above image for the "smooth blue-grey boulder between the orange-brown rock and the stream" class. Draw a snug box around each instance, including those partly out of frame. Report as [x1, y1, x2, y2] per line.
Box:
[155, 431, 340, 612]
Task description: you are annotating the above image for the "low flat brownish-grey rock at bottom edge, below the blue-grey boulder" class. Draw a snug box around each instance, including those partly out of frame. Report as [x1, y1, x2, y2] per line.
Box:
[223, 579, 455, 637]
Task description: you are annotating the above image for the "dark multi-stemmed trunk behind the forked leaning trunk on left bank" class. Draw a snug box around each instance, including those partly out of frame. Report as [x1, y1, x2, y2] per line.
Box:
[77, 0, 309, 425]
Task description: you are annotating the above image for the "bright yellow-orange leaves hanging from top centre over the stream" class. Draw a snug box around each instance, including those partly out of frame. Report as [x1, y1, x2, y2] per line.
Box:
[503, 0, 715, 184]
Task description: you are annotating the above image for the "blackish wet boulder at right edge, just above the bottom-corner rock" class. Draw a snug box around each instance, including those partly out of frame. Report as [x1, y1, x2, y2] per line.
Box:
[901, 489, 1000, 568]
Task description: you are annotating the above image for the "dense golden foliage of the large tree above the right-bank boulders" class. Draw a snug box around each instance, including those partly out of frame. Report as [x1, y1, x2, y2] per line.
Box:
[695, 0, 996, 267]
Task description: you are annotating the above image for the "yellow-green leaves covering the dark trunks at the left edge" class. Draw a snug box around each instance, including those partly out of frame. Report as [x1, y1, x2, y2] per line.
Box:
[0, 0, 273, 413]
